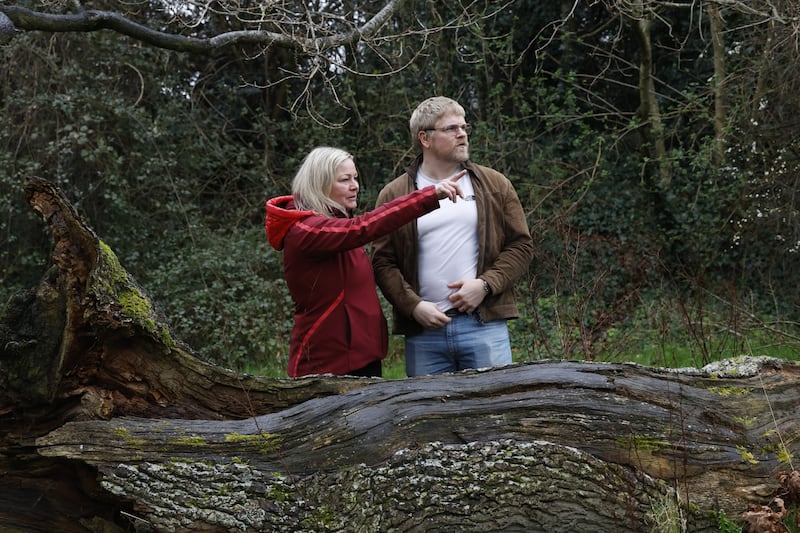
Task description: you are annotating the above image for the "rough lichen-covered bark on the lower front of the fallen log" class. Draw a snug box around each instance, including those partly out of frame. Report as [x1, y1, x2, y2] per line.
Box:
[97, 440, 676, 532]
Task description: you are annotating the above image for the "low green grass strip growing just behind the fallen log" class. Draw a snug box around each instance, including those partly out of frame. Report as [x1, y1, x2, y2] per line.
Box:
[241, 290, 800, 379]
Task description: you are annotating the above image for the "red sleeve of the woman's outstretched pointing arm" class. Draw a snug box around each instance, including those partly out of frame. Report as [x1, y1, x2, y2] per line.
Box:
[285, 186, 439, 254]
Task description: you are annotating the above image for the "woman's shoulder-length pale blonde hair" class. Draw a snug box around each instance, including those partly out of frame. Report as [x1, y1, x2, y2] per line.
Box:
[292, 146, 353, 216]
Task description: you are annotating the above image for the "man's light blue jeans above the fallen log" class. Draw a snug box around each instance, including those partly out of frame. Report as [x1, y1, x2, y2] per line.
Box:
[406, 315, 511, 377]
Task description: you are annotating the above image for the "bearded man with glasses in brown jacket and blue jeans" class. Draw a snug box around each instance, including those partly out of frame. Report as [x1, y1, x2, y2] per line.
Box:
[372, 97, 533, 376]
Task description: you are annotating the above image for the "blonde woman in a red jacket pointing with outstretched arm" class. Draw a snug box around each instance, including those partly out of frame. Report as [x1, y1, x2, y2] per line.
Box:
[265, 147, 463, 377]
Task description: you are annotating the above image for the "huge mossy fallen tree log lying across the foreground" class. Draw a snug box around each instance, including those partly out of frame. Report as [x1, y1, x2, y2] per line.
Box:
[0, 181, 800, 531]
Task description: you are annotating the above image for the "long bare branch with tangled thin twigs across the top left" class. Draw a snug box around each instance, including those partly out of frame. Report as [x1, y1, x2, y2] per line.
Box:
[0, 0, 500, 119]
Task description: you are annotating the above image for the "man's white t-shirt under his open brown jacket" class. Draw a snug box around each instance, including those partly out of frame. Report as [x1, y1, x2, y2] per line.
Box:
[417, 172, 478, 311]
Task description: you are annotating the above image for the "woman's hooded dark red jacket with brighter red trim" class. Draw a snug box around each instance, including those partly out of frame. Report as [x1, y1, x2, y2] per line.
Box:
[265, 186, 439, 377]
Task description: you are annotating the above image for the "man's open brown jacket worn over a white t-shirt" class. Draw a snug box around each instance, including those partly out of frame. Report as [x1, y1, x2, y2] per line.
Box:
[372, 156, 533, 335]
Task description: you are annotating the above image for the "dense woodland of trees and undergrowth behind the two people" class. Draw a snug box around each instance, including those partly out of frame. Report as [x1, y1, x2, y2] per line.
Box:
[0, 0, 800, 377]
